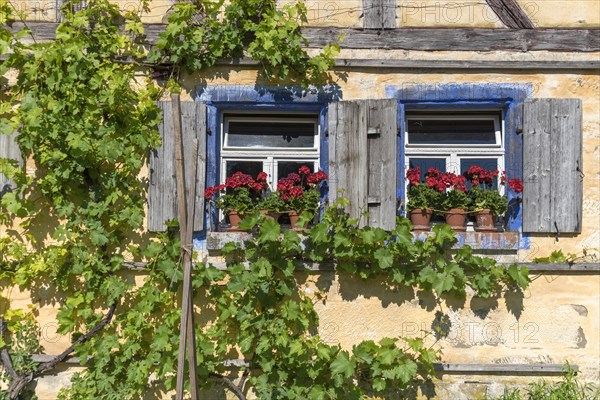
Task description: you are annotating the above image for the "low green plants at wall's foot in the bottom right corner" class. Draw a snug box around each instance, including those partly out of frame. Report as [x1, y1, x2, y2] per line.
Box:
[496, 362, 600, 400]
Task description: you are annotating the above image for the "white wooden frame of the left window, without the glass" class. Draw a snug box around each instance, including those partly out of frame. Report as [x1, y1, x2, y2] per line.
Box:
[219, 111, 321, 190]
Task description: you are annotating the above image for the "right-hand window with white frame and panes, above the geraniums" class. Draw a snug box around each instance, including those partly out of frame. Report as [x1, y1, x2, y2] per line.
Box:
[404, 111, 505, 190]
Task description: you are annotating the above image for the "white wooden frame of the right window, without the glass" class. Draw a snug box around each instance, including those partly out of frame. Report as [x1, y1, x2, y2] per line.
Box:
[404, 110, 506, 194]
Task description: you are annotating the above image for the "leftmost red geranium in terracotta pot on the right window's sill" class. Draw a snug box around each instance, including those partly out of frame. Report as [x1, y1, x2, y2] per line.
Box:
[406, 167, 440, 232]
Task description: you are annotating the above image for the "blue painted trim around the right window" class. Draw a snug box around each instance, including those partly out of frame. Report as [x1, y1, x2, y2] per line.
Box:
[385, 83, 533, 249]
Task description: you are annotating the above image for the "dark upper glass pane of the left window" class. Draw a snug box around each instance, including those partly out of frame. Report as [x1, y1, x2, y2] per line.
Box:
[227, 121, 315, 148]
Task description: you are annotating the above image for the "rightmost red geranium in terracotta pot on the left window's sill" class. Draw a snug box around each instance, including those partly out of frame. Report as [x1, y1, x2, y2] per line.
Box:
[277, 166, 327, 228]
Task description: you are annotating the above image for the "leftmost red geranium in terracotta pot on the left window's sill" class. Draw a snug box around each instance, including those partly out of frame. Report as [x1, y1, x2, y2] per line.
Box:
[204, 172, 268, 231]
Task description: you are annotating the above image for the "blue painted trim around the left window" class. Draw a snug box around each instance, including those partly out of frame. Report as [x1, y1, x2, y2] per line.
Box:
[194, 85, 342, 250]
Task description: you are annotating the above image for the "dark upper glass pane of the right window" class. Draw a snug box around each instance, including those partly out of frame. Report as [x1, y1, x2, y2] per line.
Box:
[408, 118, 497, 145]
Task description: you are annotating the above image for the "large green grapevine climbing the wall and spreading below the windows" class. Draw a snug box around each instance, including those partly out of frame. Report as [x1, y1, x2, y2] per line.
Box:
[0, 0, 529, 399]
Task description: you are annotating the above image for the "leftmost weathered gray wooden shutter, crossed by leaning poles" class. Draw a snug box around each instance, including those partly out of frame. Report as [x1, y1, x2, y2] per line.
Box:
[148, 101, 206, 232]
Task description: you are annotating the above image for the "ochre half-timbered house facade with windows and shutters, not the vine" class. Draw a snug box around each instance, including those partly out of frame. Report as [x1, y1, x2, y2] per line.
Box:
[0, 0, 600, 399]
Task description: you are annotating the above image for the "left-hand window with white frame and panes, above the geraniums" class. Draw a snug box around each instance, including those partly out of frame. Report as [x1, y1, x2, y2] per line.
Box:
[220, 113, 320, 190]
